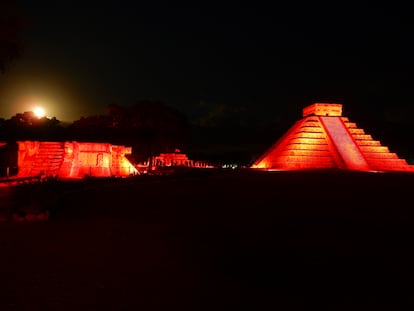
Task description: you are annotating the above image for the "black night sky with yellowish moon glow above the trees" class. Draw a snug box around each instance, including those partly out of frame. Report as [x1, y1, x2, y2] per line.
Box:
[0, 0, 414, 158]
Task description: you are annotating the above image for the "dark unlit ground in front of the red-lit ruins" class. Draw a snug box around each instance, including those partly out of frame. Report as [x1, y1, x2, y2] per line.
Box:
[0, 171, 414, 310]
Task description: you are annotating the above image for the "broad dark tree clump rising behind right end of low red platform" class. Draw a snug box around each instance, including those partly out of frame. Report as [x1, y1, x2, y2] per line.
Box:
[69, 100, 190, 162]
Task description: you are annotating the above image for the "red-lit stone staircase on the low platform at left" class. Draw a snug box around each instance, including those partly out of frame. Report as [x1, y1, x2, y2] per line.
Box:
[24, 142, 65, 176]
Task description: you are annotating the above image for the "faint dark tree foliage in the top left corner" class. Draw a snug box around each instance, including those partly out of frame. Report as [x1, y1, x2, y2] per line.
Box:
[0, 0, 26, 73]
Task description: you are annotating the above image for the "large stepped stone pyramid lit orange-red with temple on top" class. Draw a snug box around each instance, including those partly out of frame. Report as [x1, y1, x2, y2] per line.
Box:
[252, 103, 414, 172]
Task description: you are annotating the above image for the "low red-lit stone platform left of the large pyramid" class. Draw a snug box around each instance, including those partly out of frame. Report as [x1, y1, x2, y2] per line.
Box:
[18, 141, 137, 178]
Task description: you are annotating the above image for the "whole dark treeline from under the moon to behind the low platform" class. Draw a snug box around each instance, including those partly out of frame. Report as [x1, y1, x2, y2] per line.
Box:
[0, 100, 190, 162]
